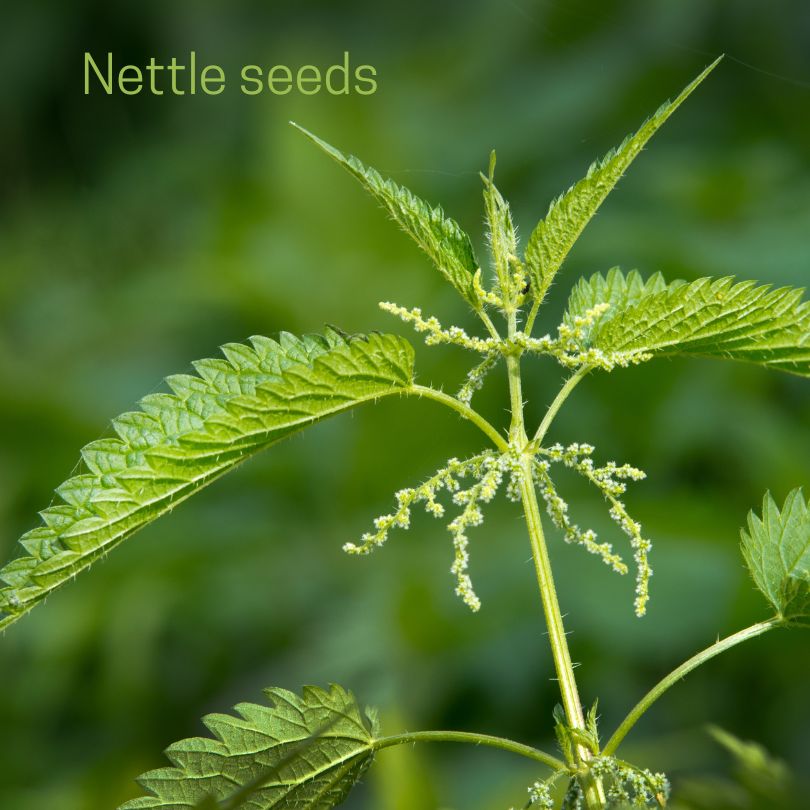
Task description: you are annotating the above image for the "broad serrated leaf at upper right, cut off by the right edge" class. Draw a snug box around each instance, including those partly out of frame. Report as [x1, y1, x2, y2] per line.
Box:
[564, 269, 810, 377]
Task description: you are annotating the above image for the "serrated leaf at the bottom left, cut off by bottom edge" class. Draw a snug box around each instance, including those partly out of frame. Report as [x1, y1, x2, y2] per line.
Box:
[119, 686, 379, 810]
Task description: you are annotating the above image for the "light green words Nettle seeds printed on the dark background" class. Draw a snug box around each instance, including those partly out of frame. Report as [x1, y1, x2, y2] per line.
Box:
[84, 51, 377, 96]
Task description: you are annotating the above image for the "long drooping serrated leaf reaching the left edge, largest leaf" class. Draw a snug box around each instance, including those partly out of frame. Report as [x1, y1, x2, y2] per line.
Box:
[0, 330, 413, 628]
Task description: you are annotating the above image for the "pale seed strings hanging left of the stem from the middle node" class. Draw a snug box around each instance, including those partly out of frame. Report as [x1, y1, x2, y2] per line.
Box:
[343, 451, 522, 611]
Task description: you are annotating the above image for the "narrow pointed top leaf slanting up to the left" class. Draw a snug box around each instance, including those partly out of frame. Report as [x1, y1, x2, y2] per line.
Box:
[290, 122, 481, 309]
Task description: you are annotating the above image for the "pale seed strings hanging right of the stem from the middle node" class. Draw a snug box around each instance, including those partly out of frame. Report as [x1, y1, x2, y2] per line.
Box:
[534, 443, 652, 616]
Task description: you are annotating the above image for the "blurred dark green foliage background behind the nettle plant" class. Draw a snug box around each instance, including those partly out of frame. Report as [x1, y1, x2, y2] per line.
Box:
[0, 0, 810, 810]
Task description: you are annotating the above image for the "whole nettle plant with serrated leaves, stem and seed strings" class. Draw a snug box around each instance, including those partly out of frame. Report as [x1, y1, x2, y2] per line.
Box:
[0, 58, 810, 810]
